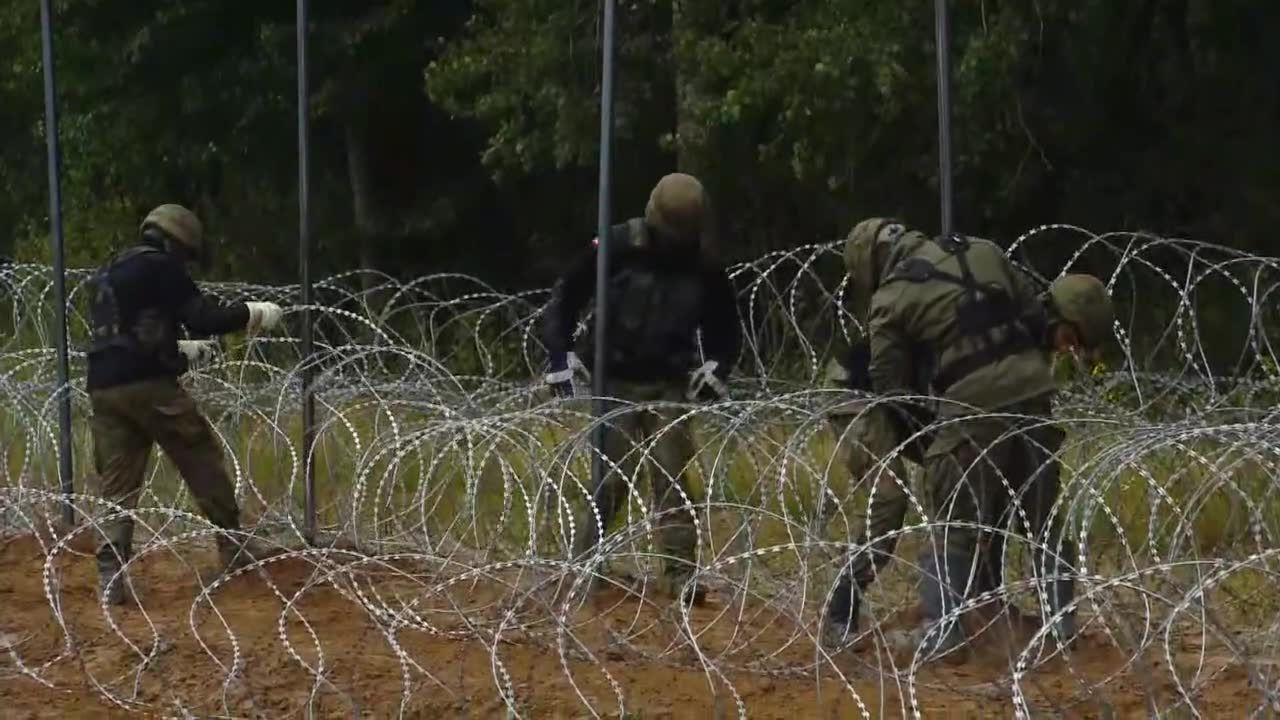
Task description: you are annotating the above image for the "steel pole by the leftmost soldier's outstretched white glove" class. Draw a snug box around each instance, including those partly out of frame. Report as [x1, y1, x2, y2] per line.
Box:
[297, 0, 316, 543]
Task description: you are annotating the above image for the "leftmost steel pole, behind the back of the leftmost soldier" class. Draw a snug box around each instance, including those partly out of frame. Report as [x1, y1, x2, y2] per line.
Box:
[40, 0, 76, 527]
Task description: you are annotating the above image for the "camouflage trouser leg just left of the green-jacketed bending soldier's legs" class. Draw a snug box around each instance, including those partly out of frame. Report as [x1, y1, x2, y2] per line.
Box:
[827, 407, 910, 624]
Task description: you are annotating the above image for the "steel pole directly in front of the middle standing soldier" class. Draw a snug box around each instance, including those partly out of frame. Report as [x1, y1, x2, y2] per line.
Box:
[591, 0, 614, 488]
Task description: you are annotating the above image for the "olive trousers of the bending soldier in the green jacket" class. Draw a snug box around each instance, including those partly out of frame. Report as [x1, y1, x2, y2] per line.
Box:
[922, 396, 1075, 630]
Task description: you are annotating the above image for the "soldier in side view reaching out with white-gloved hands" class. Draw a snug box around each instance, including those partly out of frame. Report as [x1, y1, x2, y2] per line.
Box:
[87, 205, 282, 605]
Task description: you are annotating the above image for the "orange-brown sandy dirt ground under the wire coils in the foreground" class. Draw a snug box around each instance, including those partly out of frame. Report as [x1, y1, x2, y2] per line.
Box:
[0, 525, 1260, 720]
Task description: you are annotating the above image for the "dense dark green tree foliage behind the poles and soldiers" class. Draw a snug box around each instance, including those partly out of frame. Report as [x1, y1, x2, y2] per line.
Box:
[0, 0, 1280, 287]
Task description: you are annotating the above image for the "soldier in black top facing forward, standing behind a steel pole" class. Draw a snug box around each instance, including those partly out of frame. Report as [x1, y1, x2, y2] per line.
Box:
[544, 173, 741, 603]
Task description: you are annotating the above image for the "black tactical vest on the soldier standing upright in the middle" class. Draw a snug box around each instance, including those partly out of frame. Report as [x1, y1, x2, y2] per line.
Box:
[591, 218, 705, 380]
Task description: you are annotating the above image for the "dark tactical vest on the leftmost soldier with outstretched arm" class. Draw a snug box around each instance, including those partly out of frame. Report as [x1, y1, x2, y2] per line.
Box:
[88, 246, 183, 372]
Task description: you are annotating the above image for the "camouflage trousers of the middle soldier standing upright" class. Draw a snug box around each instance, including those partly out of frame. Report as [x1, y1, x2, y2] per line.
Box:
[573, 383, 698, 585]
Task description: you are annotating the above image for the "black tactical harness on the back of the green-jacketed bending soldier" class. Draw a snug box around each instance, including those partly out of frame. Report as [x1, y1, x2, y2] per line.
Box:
[886, 236, 1046, 393]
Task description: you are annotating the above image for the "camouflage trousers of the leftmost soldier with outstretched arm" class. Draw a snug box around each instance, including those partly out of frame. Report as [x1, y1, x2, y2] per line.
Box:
[90, 379, 239, 566]
